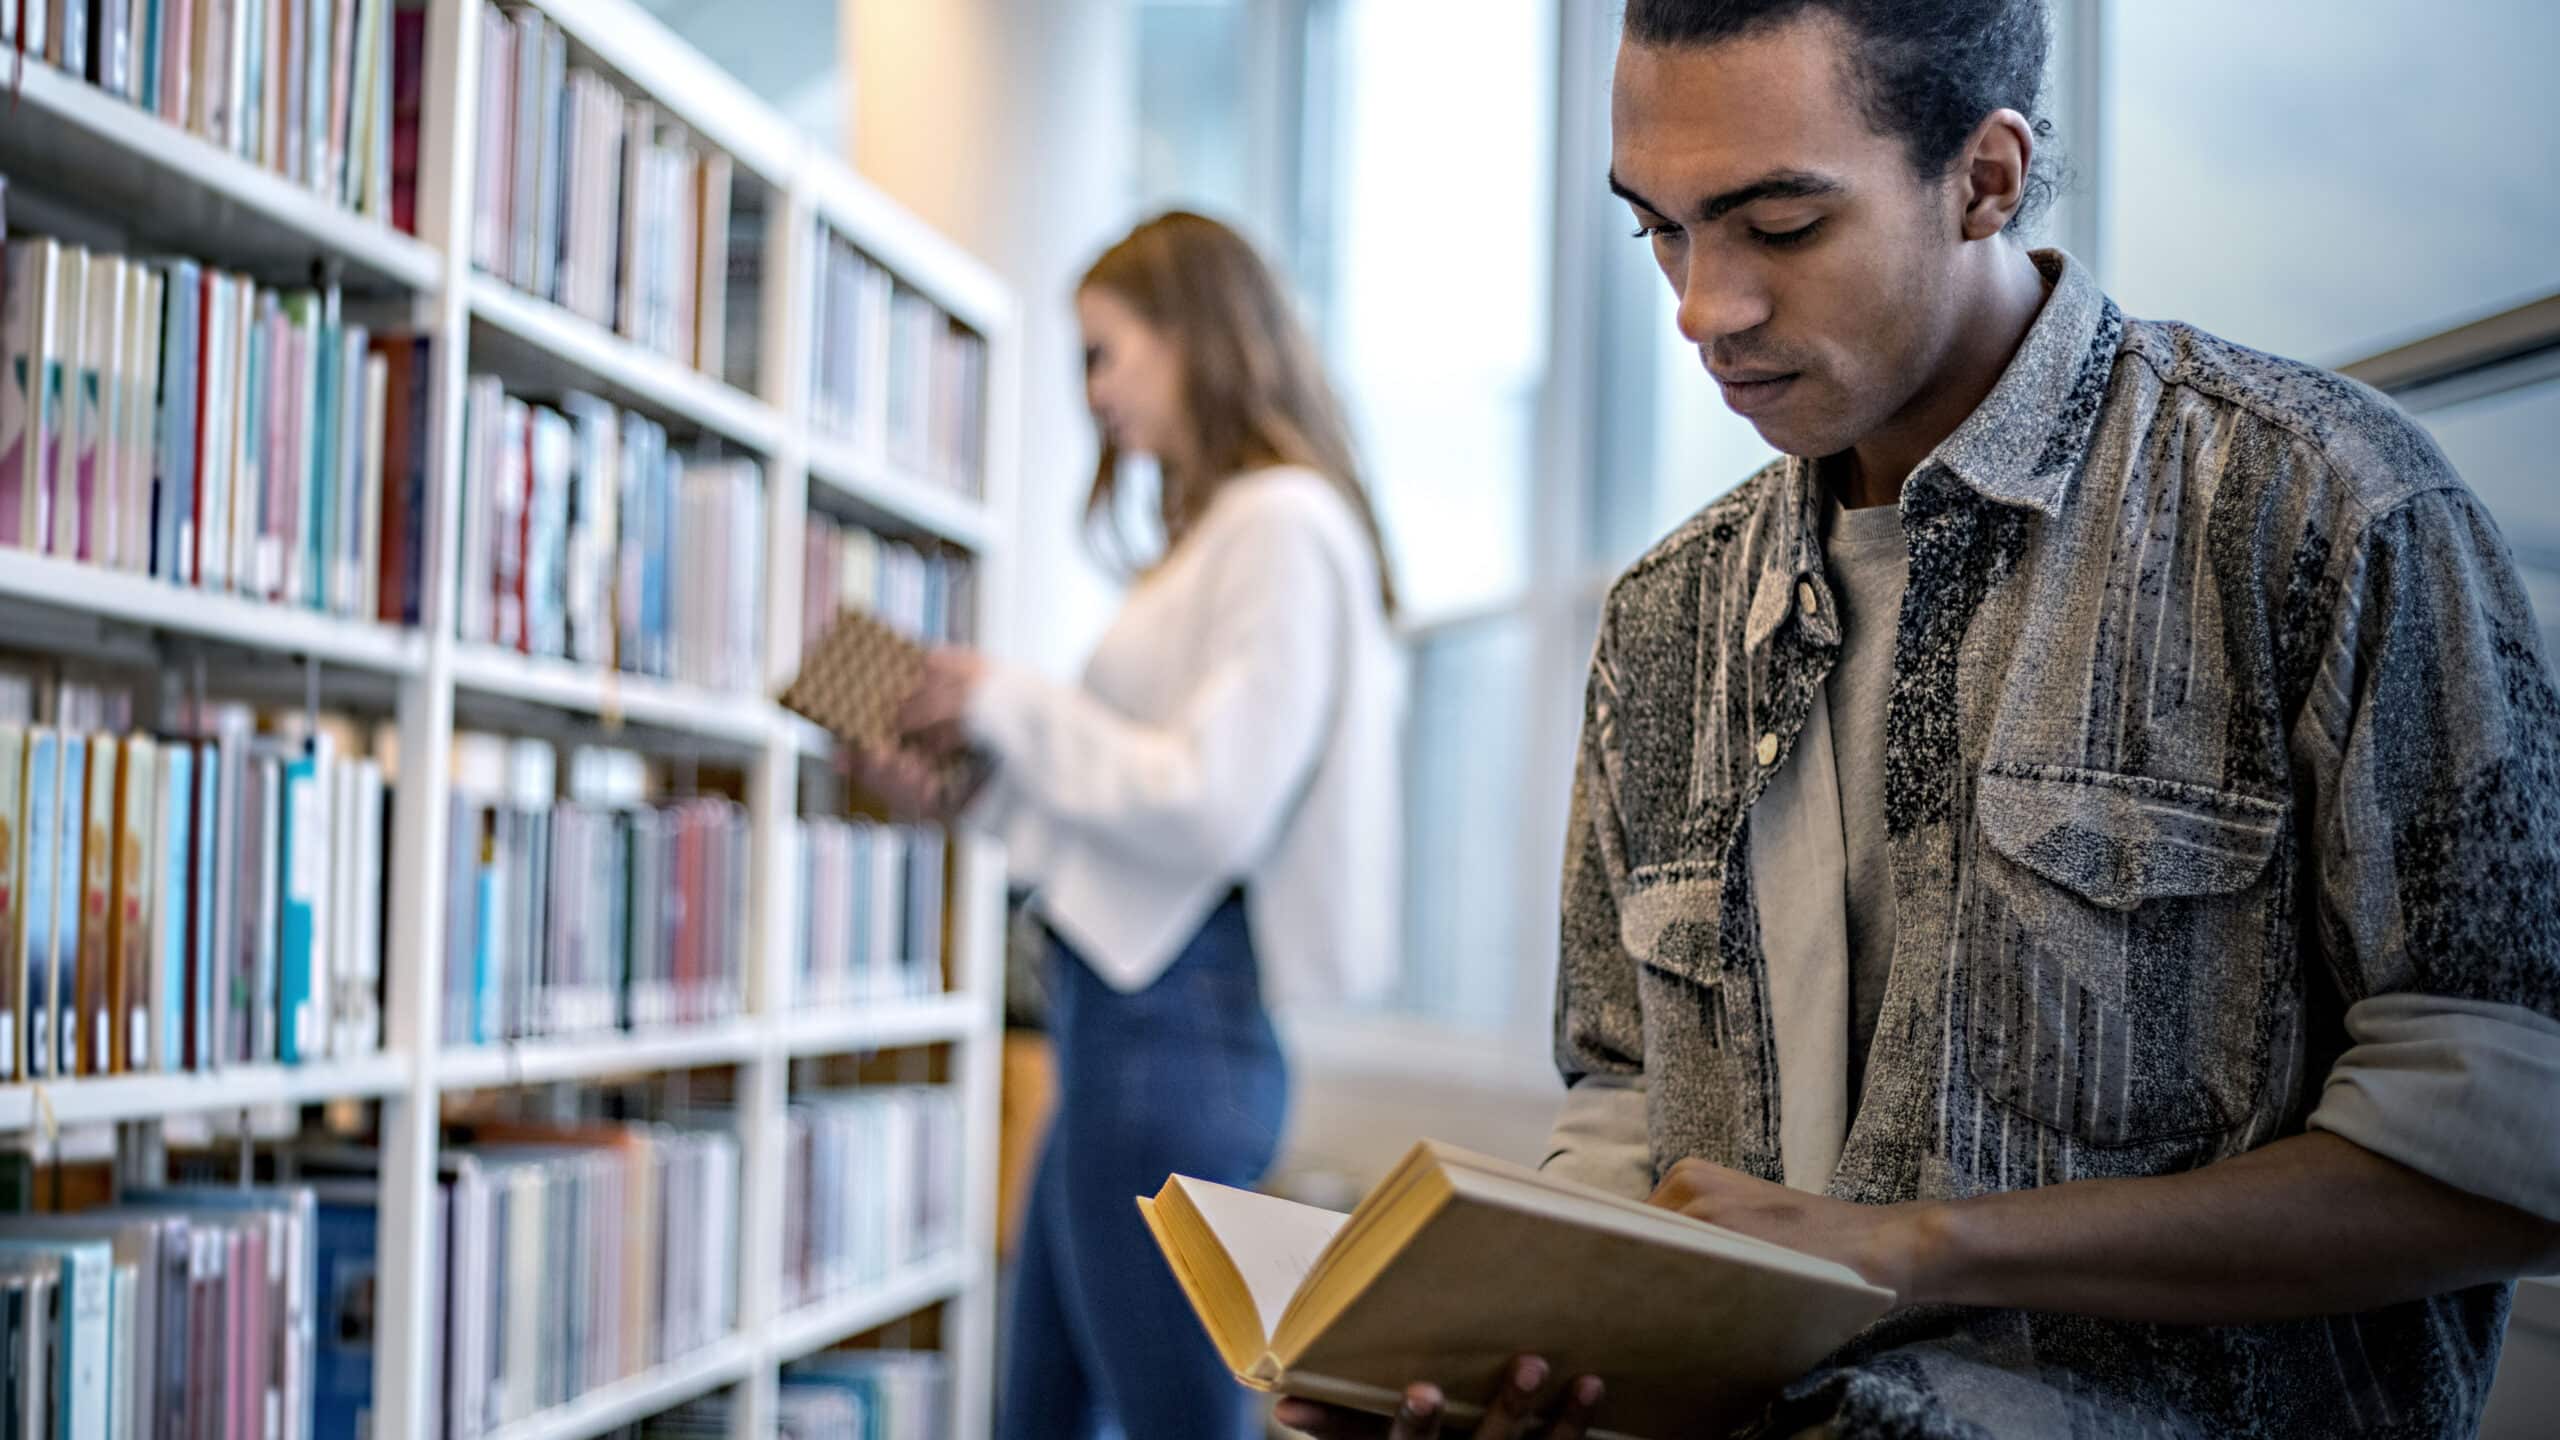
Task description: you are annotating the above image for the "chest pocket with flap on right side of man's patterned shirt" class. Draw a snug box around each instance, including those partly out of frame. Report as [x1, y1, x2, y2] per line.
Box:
[1958, 764, 2291, 1145]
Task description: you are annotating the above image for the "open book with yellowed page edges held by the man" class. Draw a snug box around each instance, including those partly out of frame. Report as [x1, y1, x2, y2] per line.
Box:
[1137, 1140, 1894, 1440]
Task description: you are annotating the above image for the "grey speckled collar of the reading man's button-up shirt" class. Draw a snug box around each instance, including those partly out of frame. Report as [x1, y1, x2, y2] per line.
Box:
[1746, 251, 2125, 651]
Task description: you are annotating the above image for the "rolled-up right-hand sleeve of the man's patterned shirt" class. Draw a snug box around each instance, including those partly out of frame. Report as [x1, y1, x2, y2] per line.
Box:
[2296, 484, 2560, 1220]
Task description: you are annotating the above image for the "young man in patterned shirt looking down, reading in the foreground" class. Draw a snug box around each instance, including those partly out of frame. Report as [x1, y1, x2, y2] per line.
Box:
[1283, 0, 2560, 1440]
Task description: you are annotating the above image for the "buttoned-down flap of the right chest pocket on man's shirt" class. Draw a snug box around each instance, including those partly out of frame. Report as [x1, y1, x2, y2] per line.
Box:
[1976, 764, 2286, 910]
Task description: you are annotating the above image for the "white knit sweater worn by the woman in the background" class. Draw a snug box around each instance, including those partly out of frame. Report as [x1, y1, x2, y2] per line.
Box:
[963, 469, 1405, 1004]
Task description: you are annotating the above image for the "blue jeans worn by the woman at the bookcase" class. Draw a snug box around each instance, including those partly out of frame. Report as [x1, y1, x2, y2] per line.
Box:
[996, 892, 1288, 1440]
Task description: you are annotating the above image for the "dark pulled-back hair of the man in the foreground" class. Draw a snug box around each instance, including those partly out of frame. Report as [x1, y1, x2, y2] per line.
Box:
[1626, 0, 2063, 233]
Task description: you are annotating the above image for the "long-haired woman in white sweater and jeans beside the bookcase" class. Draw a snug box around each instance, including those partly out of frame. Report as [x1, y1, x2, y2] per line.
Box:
[855, 213, 1403, 1440]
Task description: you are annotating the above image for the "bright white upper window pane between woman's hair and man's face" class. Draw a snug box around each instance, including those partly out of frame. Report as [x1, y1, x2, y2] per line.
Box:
[1308, 0, 1554, 615]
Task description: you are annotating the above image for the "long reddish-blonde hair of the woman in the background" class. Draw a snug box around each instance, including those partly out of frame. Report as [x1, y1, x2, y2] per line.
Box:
[1075, 210, 1395, 615]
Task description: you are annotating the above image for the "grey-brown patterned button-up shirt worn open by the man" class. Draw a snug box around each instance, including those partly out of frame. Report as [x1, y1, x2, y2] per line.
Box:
[1556, 254, 2560, 1437]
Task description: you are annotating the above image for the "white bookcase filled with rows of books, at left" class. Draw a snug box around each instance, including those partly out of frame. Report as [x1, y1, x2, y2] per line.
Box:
[0, 0, 1014, 1440]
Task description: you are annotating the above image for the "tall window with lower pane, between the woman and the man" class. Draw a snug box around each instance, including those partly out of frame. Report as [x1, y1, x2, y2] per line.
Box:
[1132, 0, 1566, 1033]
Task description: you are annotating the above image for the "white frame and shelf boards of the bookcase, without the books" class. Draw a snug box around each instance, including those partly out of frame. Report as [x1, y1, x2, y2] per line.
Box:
[0, 0, 1016, 1440]
